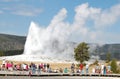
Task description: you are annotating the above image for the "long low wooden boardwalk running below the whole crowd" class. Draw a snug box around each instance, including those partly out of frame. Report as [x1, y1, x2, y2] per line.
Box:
[0, 71, 120, 79]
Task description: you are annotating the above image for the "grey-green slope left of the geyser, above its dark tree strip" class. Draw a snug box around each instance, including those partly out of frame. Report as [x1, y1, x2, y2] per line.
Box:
[0, 34, 26, 50]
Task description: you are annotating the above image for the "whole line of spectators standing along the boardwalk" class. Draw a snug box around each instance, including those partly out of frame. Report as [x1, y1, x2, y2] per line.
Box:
[0, 60, 111, 75]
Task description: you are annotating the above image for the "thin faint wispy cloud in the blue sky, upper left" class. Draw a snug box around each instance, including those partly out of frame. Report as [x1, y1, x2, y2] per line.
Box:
[2, 5, 43, 16]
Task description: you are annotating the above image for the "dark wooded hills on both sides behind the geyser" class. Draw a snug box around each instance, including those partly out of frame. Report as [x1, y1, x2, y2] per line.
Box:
[0, 34, 120, 60]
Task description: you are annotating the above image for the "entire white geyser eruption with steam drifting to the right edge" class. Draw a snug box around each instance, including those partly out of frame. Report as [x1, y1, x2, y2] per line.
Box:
[24, 3, 120, 59]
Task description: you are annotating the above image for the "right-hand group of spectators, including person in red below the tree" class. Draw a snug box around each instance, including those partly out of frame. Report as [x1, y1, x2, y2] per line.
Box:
[71, 63, 111, 75]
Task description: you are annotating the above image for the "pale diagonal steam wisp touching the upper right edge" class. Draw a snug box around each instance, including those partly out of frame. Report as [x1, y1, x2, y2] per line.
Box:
[93, 4, 120, 29]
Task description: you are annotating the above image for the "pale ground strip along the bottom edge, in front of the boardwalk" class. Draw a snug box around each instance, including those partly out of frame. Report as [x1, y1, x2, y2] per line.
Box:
[0, 76, 120, 79]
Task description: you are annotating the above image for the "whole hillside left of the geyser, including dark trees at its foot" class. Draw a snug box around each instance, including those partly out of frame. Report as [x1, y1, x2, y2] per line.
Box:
[0, 34, 26, 56]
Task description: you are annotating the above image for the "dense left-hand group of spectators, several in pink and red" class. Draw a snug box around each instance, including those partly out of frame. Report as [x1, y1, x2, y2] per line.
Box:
[0, 60, 51, 74]
